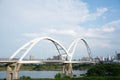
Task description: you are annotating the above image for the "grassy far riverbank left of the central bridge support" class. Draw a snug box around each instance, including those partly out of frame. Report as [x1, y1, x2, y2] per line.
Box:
[0, 64, 62, 71]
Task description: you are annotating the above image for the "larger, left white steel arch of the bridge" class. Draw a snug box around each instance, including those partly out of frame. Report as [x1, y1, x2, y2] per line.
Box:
[10, 37, 68, 61]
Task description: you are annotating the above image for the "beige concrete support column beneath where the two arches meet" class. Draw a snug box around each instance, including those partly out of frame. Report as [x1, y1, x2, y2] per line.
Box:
[62, 63, 73, 77]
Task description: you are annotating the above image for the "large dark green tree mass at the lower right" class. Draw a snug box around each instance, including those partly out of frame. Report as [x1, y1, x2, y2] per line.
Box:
[87, 63, 120, 76]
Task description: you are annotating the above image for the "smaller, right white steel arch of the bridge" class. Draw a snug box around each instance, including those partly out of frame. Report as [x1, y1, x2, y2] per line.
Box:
[68, 38, 92, 61]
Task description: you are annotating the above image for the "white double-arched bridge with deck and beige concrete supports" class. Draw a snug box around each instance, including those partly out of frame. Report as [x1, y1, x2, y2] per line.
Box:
[0, 37, 95, 80]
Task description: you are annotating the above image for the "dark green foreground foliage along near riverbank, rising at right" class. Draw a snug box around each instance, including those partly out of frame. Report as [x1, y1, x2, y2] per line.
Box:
[20, 63, 120, 80]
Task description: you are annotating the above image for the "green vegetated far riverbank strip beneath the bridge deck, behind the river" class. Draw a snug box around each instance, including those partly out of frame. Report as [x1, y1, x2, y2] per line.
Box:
[0, 64, 93, 71]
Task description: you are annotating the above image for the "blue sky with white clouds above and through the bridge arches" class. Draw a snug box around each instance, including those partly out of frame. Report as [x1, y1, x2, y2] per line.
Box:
[0, 0, 120, 59]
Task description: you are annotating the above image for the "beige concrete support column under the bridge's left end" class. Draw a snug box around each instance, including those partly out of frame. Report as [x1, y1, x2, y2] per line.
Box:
[7, 63, 21, 80]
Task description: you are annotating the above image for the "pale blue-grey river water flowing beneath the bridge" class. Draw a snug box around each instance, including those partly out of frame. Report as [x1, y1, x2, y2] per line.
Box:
[0, 70, 86, 79]
